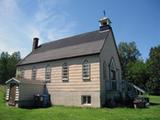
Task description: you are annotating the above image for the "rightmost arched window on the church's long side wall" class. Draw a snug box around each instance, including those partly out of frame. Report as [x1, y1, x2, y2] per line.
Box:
[82, 60, 90, 81]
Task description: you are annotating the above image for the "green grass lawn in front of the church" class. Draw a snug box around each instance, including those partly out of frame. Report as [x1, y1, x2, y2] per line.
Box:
[0, 86, 160, 120]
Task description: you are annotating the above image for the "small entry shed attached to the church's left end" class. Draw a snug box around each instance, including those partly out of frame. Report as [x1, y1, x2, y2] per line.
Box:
[6, 78, 45, 107]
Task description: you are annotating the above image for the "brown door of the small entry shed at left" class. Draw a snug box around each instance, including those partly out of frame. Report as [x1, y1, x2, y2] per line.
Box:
[8, 84, 16, 106]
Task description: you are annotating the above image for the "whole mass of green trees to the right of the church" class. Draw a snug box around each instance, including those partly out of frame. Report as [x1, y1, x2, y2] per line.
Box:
[118, 42, 160, 95]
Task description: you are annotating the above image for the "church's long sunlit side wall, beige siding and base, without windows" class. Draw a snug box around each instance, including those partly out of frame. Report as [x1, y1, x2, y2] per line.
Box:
[16, 55, 100, 107]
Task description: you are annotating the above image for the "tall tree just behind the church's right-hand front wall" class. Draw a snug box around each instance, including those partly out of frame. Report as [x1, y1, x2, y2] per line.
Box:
[118, 42, 141, 79]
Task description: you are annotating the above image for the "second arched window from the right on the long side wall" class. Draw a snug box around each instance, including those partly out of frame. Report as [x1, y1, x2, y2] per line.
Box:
[62, 63, 68, 82]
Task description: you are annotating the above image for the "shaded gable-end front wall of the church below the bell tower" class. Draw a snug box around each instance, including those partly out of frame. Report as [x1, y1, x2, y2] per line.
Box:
[100, 30, 121, 104]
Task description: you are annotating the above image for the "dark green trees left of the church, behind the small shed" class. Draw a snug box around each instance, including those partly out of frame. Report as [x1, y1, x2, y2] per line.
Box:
[0, 52, 20, 84]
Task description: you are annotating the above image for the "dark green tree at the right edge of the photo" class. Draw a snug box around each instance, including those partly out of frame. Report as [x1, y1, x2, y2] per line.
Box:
[147, 45, 160, 95]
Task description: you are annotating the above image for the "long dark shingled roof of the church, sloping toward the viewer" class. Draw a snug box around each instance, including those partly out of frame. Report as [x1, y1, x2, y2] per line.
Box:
[18, 30, 109, 65]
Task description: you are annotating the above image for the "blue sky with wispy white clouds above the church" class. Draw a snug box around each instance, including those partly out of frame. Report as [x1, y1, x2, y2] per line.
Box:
[0, 0, 160, 59]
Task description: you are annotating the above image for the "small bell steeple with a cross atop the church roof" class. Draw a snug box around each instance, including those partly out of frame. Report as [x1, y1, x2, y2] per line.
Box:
[99, 11, 111, 31]
